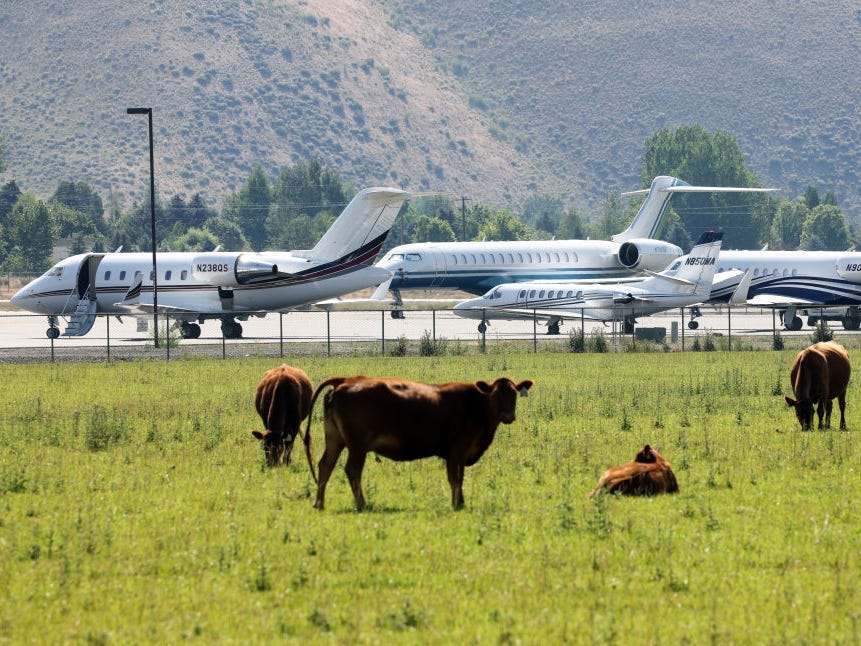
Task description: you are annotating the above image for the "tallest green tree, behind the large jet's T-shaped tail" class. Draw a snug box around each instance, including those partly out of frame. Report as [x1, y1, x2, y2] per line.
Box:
[641, 126, 769, 249]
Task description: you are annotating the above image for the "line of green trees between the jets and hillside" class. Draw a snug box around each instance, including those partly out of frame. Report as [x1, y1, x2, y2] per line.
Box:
[0, 126, 856, 272]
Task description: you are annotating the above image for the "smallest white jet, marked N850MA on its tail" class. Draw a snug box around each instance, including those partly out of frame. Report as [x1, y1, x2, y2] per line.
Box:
[454, 231, 723, 334]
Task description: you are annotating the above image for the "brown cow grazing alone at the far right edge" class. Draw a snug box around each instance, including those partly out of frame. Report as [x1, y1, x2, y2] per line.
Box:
[783, 341, 852, 431]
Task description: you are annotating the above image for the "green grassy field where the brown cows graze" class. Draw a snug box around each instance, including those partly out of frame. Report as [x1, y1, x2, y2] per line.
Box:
[0, 348, 861, 644]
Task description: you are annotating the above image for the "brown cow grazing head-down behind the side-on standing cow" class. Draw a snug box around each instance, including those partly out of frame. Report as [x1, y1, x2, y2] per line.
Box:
[251, 364, 313, 467]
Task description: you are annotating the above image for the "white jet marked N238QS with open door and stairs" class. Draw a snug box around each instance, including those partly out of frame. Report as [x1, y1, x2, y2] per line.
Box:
[11, 188, 410, 339]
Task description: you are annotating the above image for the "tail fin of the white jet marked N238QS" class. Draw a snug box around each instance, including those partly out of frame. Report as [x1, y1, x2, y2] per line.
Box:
[302, 188, 410, 264]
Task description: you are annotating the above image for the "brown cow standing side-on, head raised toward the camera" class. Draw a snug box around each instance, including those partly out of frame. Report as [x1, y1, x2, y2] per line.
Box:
[305, 376, 533, 511]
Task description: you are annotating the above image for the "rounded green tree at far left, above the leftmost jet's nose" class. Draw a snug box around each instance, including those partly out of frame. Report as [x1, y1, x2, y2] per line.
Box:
[5, 193, 57, 272]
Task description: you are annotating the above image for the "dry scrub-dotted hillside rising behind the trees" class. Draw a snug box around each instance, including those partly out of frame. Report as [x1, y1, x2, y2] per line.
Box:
[0, 0, 861, 221]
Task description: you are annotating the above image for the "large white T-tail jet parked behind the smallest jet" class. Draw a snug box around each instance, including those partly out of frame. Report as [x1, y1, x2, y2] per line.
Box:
[374, 176, 776, 318]
